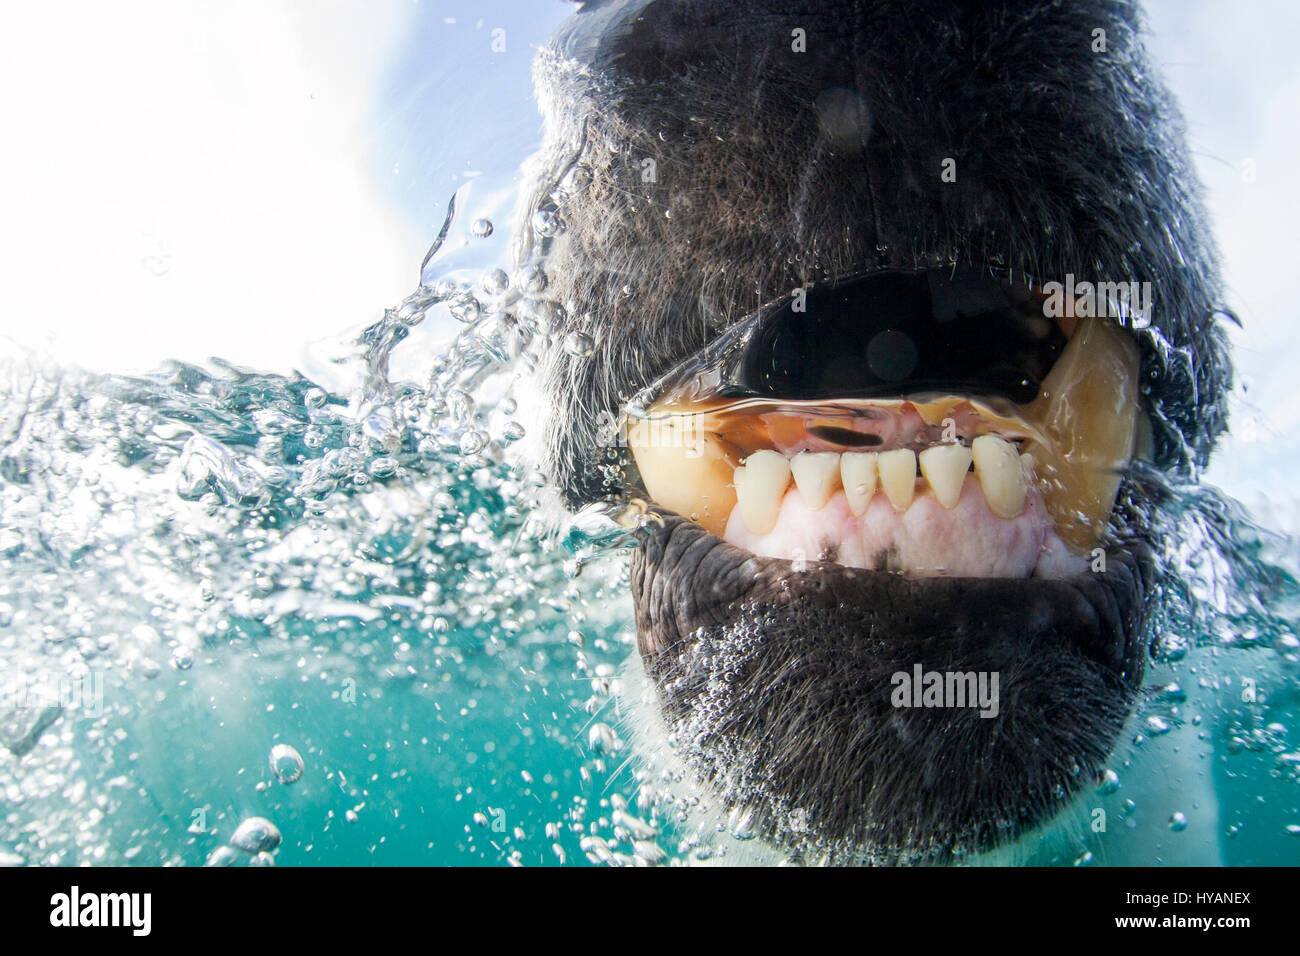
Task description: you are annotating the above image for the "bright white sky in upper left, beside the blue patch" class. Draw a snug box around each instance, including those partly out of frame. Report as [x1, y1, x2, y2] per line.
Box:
[0, 0, 425, 371]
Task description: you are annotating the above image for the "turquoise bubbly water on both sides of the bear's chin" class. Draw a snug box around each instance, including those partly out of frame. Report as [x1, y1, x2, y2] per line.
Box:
[0, 192, 1300, 865]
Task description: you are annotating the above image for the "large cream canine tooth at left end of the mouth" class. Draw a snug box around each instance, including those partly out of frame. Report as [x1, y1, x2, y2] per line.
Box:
[627, 415, 738, 537]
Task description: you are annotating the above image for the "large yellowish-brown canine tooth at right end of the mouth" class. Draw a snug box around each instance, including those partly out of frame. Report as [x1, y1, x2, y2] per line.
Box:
[1027, 316, 1139, 550]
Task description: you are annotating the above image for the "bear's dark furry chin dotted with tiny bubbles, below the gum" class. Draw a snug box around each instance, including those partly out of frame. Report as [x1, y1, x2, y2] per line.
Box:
[632, 512, 1151, 862]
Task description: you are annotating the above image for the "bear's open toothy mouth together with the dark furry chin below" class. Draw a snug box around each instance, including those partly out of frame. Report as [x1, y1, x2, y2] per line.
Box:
[624, 269, 1149, 860]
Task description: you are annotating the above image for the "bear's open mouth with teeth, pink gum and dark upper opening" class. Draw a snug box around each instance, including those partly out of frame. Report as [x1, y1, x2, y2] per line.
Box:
[627, 271, 1143, 578]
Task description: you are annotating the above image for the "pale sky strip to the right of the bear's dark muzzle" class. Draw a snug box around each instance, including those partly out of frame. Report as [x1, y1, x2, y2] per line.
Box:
[1147, 0, 1300, 515]
